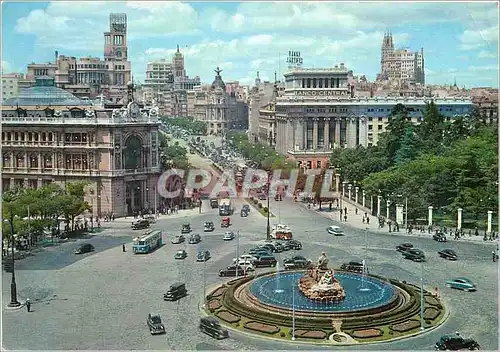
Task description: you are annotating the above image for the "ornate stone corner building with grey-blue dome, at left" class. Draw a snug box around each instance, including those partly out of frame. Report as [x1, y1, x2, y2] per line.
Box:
[1, 77, 160, 216]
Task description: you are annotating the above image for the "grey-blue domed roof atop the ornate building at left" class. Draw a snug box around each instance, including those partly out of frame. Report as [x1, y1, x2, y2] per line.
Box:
[2, 77, 91, 106]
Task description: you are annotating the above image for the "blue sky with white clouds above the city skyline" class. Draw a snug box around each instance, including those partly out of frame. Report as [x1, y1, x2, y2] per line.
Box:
[2, 1, 499, 88]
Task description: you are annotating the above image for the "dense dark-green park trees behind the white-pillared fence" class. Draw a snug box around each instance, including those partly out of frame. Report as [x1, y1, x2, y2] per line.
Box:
[331, 102, 498, 219]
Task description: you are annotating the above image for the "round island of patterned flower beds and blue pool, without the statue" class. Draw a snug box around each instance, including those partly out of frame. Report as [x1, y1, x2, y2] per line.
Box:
[203, 270, 448, 346]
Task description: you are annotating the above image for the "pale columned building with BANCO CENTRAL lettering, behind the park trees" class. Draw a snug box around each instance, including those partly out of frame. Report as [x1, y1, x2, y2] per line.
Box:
[266, 64, 472, 168]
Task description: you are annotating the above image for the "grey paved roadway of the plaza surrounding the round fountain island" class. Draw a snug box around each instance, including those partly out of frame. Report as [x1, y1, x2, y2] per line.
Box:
[2, 146, 498, 350]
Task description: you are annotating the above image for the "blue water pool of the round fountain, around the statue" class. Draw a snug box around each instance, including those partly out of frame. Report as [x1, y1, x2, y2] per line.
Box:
[249, 272, 397, 312]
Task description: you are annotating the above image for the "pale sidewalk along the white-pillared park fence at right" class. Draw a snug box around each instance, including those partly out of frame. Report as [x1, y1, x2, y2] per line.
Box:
[301, 197, 498, 245]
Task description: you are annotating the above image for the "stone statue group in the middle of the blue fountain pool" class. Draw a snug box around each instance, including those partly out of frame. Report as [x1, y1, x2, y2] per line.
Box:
[299, 252, 345, 302]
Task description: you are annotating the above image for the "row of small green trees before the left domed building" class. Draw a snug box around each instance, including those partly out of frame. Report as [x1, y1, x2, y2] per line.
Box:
[2, 181, 92, 239]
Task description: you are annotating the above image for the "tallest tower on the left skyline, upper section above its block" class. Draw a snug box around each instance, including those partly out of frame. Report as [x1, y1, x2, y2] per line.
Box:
[104, 13, 128, 61]
